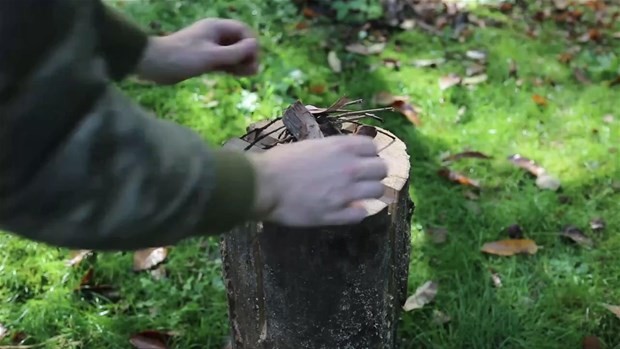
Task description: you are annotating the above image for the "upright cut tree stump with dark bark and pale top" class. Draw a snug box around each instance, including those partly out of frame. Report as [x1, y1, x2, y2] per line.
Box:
[220, 103, 414, 349]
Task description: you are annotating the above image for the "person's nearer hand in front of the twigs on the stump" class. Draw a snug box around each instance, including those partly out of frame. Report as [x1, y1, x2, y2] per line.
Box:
[251, 135, 387, 227]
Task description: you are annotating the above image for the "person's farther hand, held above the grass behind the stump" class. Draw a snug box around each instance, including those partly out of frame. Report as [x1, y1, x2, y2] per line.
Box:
[137, 18, 258, 84]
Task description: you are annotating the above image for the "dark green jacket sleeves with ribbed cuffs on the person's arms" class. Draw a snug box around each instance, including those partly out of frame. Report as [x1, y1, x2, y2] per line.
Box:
[0, 0, 255, 250]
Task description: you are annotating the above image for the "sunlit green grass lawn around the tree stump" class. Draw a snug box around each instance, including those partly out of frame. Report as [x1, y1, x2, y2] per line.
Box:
[0, 0, 620, 349]
